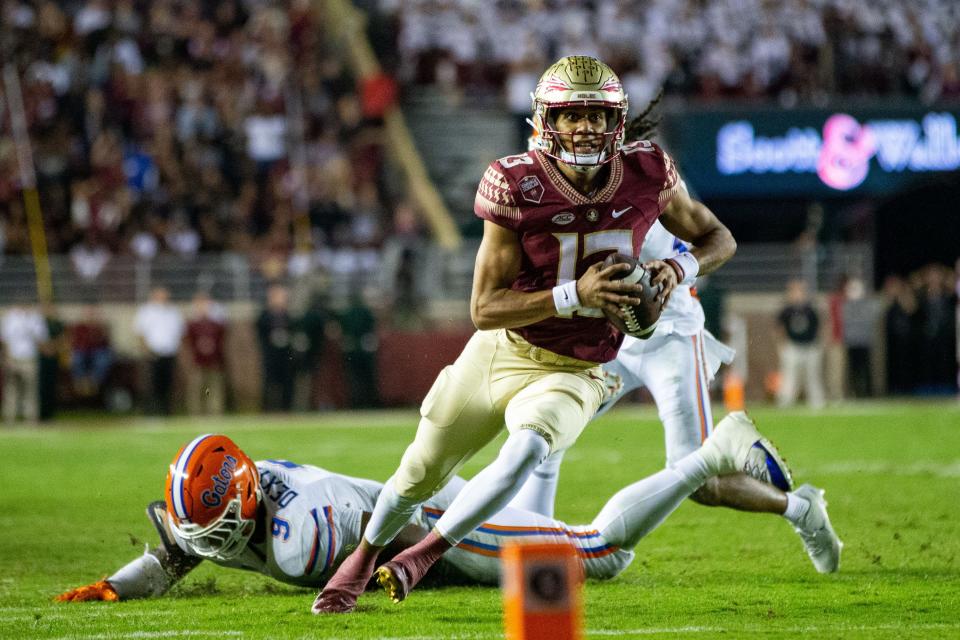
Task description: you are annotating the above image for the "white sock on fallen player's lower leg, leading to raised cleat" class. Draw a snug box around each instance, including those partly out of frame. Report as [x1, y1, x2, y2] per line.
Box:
[592, 462, 706, 551]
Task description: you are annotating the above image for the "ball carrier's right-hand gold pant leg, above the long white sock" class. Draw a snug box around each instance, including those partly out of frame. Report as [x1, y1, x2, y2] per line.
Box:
[505, 367, 604, 453]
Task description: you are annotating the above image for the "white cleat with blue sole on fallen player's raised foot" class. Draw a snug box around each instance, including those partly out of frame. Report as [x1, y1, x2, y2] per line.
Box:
[700, 411, 793, 491]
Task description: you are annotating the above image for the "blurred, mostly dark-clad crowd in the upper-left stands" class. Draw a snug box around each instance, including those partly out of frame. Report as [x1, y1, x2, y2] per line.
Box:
[0, 0, 417, 277]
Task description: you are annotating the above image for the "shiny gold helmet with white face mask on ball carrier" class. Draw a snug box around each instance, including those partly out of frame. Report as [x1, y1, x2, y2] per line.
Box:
[530, 56, 627, 169]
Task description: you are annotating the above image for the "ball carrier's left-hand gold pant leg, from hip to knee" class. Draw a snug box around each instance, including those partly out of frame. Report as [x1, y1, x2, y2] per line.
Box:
[393, 331, 503, 499]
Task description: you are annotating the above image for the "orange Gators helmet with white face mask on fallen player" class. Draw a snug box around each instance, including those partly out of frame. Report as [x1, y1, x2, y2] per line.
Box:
[165, 434, 260, 560]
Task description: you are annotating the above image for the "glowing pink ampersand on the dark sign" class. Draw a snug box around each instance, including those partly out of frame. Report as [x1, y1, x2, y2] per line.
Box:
[817, 113, 877, 191]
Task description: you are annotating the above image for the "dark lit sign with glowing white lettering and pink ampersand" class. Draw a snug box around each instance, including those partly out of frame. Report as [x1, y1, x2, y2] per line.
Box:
[666, 109, 960, 197]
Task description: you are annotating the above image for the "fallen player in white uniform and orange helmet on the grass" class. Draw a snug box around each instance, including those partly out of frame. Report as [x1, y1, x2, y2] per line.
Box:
[57, 414, 790, 602]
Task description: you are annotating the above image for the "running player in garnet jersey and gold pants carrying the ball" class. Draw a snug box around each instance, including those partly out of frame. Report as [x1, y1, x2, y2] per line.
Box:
[313, 56, 736, 613]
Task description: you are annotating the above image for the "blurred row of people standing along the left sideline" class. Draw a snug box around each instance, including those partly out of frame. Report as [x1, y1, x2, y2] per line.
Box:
[0, 284, 380, 423]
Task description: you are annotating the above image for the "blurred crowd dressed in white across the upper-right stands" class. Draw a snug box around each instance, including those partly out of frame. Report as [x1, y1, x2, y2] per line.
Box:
[379, 0, 960, 110]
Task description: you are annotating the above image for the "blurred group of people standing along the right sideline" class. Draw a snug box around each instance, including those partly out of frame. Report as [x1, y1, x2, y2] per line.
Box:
[767, 261, 960, 408]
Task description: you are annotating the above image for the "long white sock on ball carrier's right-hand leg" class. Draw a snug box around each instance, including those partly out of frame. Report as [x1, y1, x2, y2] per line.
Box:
[435, 429, 550, 545]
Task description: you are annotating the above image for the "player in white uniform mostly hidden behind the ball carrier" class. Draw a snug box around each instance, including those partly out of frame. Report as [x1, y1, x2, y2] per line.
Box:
[511, 107, 843, 573]
